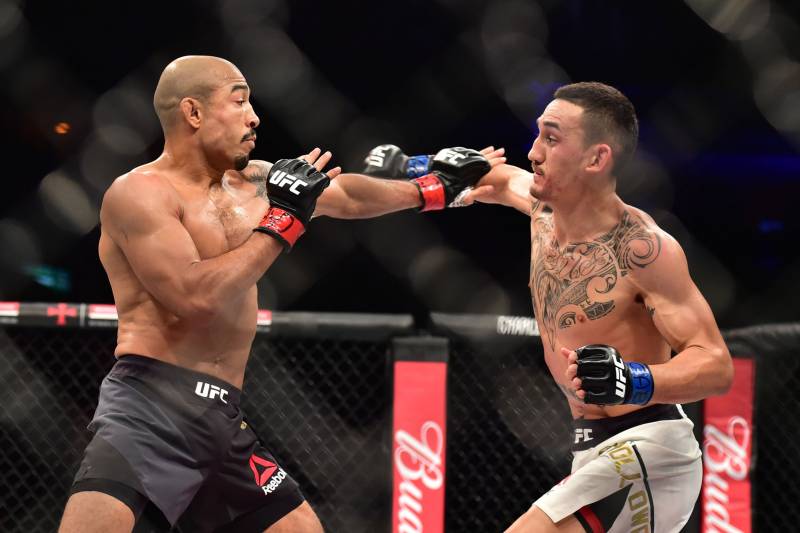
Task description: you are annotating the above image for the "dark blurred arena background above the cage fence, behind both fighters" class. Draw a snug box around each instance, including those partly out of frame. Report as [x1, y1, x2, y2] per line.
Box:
[0, 0, 800, 327]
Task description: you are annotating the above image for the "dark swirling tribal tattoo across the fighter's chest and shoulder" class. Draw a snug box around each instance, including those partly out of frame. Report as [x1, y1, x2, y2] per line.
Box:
[531, 212, 661, 350]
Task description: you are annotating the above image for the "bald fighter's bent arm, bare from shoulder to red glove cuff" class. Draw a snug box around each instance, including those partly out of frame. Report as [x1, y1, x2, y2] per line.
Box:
[100, 173, 283, 323]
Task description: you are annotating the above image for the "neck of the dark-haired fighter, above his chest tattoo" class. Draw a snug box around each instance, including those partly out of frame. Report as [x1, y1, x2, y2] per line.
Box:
[552, 192, 625, 244]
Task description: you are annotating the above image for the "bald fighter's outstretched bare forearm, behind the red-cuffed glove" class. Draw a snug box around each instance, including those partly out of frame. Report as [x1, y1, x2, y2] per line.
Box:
[317, 174, 422, 218]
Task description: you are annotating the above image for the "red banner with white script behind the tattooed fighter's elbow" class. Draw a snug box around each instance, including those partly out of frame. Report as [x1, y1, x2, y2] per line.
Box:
[701, 358, 755, 533]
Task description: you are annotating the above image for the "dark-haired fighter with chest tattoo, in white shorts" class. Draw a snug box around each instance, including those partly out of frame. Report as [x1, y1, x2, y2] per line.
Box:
[473, 83, 733, 533]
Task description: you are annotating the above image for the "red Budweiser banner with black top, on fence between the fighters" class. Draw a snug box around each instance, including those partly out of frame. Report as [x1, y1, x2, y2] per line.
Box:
[392, 337, 447, 533]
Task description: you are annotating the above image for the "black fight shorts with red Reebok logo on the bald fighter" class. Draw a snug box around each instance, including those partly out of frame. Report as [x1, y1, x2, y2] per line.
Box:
[71, 355, 303, 532]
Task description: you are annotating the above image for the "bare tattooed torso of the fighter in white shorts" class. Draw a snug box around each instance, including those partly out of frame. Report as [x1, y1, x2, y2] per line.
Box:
[530, 200, 670, 418]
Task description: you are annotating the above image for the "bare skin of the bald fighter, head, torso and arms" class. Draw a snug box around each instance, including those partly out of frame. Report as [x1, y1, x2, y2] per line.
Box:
[99, 56, 432, 387]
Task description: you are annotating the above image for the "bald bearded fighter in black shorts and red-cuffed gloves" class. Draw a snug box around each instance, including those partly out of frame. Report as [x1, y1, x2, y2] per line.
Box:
[60, 56, 501, 533]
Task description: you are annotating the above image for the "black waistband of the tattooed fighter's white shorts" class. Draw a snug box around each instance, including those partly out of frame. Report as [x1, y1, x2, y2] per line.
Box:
[572, 404, 683, 452]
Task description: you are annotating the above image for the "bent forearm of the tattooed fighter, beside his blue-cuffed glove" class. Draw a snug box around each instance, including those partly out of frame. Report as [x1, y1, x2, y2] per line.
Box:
[650, 346, 733, 403]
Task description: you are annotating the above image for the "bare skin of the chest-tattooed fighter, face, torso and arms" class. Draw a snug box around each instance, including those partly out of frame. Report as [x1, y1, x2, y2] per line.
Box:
[469, 99, 732, 419]
